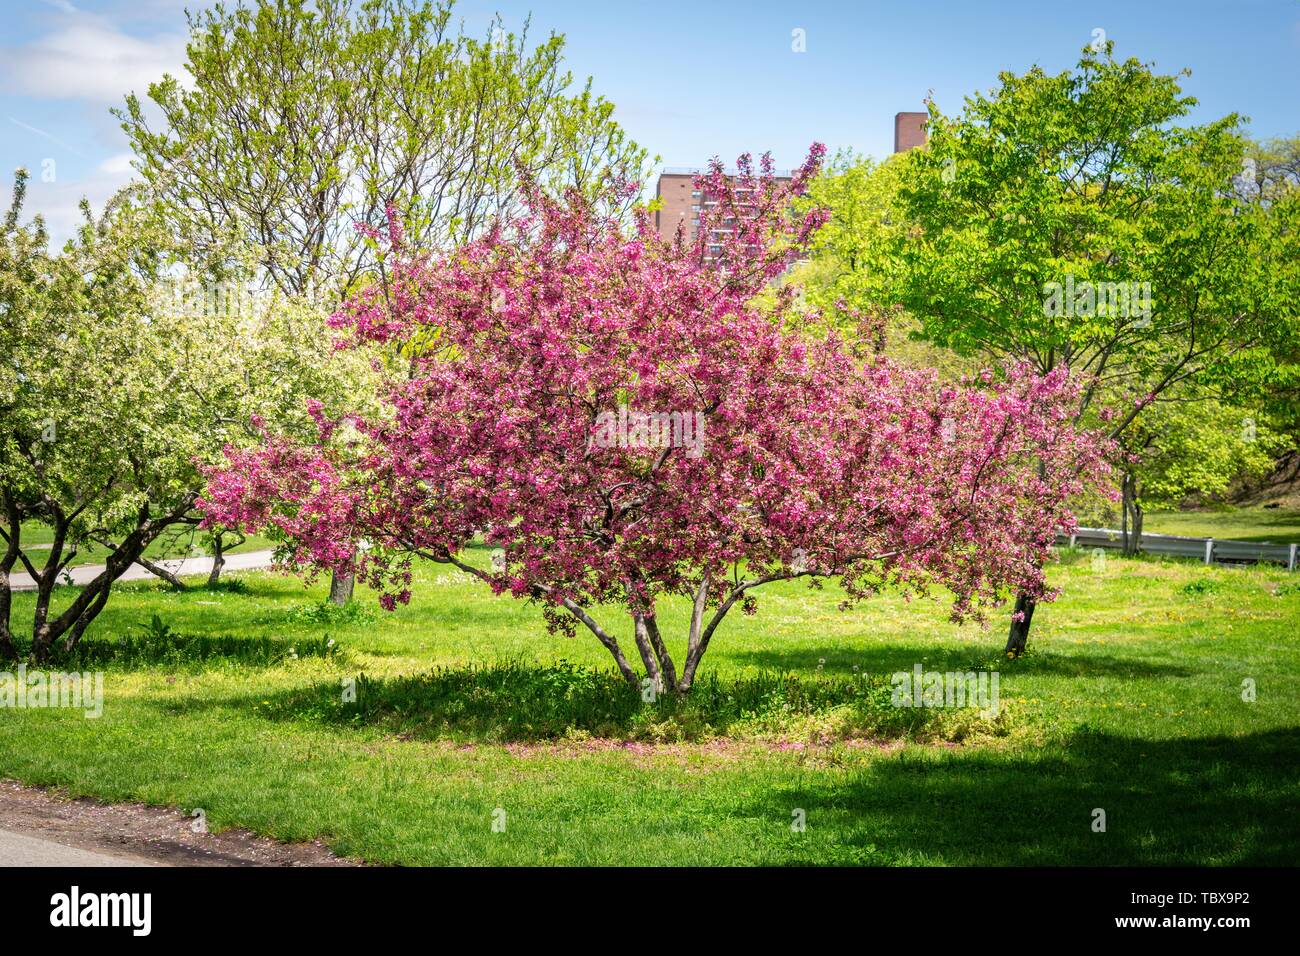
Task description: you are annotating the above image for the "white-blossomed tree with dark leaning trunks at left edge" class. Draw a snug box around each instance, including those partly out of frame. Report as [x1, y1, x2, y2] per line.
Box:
[0, 170, 359, 662]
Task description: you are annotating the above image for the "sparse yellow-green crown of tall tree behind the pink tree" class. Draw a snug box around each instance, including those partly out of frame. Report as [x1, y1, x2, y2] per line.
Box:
[116, 0, 646, 306]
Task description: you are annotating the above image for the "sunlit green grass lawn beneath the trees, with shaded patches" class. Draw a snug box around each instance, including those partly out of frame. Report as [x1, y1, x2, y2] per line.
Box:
[0, 538, 1300, 865]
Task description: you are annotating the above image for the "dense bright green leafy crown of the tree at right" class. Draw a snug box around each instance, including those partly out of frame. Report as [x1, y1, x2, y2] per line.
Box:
[811, 44, 1300, 654]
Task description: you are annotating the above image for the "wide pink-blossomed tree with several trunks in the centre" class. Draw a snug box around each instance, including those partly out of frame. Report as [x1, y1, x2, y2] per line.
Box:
[200, 146, 1102, 693]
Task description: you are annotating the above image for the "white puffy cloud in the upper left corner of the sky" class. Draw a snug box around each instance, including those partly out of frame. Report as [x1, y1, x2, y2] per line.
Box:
[0, 15, 186, 104]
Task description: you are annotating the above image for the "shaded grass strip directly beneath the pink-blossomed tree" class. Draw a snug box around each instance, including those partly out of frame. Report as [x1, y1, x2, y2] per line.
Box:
[147, 661, 1010, 743]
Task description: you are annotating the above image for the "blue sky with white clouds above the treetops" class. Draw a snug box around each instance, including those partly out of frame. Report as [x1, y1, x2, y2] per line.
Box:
[0, 0, 1300, 234]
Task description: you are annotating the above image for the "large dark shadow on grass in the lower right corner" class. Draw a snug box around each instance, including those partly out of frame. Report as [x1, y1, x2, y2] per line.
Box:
[759, 728, 1300, 866]
